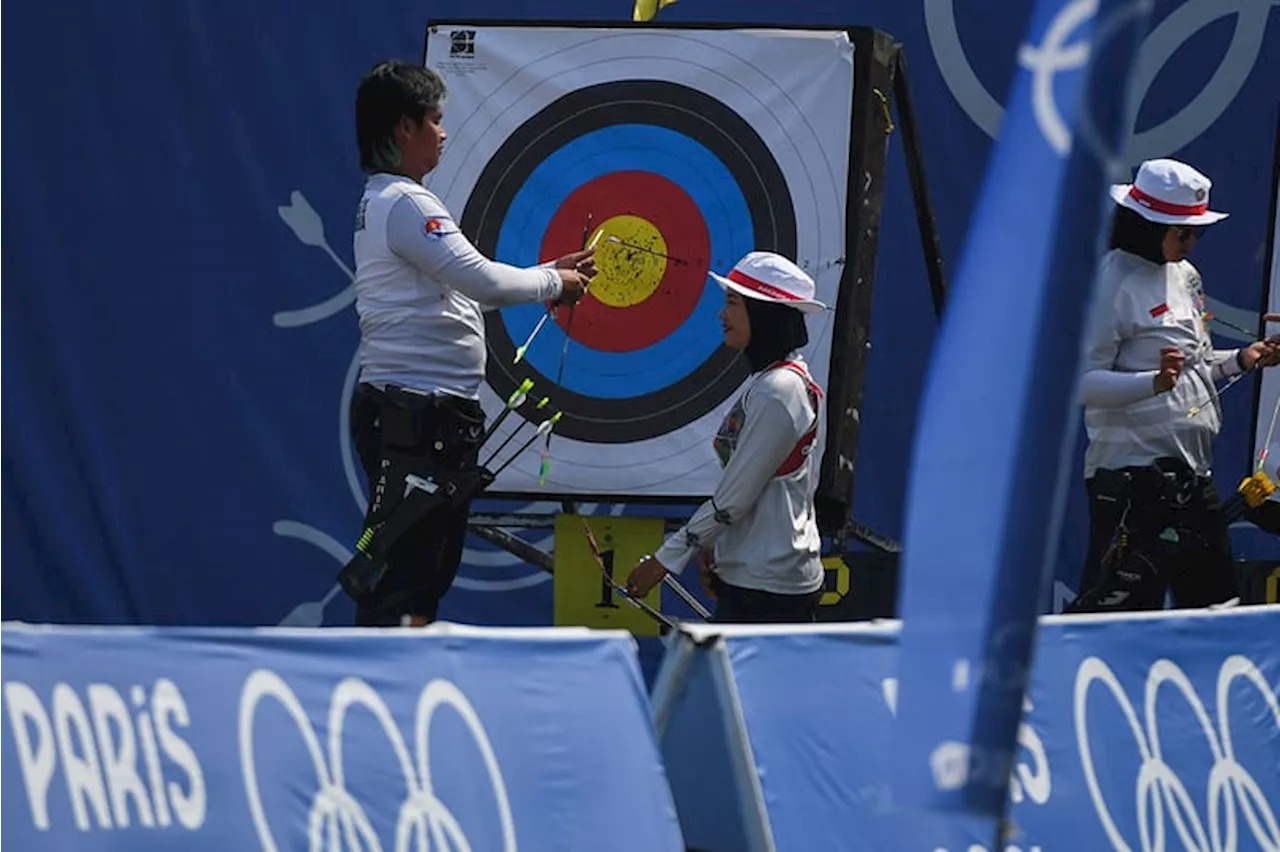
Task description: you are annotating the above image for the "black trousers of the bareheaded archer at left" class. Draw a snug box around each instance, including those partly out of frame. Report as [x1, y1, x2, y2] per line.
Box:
[351, 384, 484, 627]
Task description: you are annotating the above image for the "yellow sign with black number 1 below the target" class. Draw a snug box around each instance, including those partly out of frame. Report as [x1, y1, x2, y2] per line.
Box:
[553, 514, 664, 636]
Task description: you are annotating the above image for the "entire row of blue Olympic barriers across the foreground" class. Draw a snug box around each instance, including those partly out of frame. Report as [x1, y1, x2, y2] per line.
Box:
[0, 608, 1280, 852]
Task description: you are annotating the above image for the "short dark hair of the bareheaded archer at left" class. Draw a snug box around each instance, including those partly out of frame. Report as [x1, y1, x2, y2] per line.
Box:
[356, 59, 445, 171]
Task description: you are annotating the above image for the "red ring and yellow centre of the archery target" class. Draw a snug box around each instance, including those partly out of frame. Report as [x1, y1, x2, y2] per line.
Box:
[539, 171, 710, 352]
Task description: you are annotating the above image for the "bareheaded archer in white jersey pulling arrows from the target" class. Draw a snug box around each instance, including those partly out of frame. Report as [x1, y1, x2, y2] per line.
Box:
[351, 61, 595, 626]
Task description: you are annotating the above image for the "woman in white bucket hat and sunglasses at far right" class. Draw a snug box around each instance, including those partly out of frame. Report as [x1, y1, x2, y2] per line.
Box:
[1068, 160, 1280, 611]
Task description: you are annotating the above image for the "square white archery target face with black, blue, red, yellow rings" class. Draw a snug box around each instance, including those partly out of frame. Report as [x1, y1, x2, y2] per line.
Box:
[426, 24, 852, 498]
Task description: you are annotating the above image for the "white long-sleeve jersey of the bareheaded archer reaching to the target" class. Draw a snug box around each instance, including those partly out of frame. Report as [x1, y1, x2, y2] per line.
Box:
[353, 174, 561, 399]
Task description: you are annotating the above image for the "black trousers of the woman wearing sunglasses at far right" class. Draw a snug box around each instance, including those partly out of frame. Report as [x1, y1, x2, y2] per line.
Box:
[1068, 467, 1238, 611]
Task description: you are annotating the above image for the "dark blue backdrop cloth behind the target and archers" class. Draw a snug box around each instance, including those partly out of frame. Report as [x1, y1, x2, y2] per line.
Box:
[0, 0, 1280, 626]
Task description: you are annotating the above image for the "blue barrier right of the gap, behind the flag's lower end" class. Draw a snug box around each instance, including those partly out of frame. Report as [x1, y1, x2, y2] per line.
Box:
[653, 606, 1280, 852]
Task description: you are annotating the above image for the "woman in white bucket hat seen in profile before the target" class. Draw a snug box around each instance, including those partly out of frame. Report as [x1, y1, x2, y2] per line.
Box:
[627, 252, 827, 622]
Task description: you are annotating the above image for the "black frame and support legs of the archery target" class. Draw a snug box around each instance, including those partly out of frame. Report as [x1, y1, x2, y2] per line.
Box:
[422, 18, 946, 572]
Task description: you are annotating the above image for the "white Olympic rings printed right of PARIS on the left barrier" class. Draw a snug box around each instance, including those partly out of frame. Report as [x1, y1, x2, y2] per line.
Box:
[239, 669, 516, 852]
